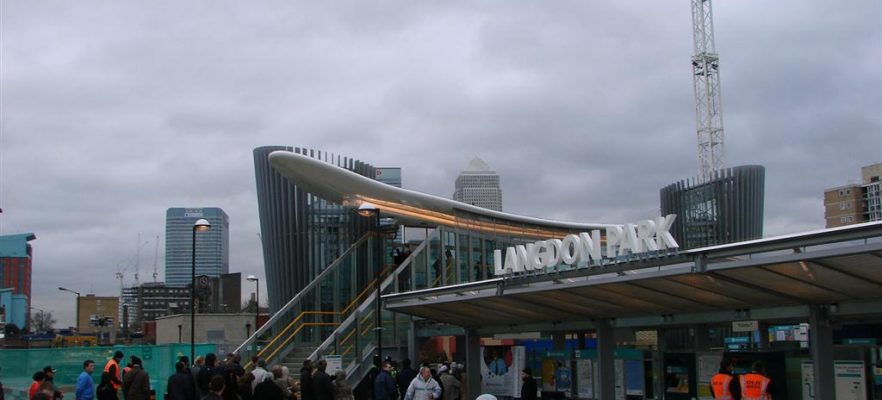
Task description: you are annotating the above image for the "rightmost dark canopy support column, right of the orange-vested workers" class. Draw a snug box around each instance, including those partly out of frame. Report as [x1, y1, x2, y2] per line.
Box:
[809, 305, 836, 399]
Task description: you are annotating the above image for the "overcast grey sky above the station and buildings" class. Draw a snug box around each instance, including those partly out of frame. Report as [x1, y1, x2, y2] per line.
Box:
[0, 0, 882, 326]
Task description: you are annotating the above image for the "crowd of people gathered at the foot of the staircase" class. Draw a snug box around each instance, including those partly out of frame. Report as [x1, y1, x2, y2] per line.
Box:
[18, 351, 488, 400]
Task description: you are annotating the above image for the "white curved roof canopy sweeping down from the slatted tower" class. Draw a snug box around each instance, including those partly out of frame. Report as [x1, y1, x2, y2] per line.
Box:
[269, 151, 619, 236]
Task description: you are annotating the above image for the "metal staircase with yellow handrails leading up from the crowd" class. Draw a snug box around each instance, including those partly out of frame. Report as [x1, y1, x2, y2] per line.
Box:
[229, 231, 437, 386]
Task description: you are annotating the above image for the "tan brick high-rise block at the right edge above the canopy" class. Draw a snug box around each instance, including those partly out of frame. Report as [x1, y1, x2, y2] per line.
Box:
[824, 163, 882, 228]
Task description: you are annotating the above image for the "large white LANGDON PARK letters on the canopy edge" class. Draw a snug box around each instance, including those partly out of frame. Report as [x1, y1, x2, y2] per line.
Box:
[493, 214, 680, 276]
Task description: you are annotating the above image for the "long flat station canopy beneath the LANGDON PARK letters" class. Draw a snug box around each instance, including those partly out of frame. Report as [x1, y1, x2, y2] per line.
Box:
[383, 222, 882, 334]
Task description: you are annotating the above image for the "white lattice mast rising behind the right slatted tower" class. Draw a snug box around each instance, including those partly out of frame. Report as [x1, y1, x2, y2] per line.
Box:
[692, 0, 725, 182]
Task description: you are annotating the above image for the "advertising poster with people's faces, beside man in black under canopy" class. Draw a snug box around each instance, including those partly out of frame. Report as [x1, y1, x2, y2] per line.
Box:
[481, 346, 526, 397]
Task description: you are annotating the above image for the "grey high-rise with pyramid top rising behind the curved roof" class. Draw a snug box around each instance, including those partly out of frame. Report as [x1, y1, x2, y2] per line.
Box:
[453, 157, 502, 211]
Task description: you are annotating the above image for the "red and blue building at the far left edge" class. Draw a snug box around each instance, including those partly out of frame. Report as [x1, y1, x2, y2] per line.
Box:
[0, 233, 37, 328]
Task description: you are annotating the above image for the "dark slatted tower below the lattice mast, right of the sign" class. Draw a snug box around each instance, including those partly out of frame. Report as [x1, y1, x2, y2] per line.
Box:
[660, 165, 766, 249]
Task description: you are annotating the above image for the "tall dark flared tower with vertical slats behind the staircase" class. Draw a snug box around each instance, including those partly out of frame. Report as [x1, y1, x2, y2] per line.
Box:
[254, 146, 376, 311]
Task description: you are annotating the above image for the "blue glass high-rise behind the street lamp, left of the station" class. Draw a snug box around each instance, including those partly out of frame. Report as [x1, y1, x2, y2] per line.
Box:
[165, 207, 230, 287]
